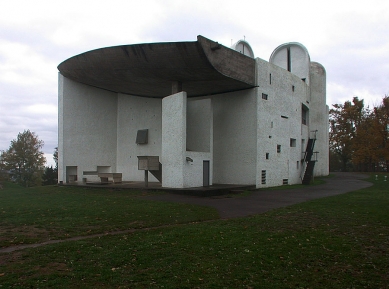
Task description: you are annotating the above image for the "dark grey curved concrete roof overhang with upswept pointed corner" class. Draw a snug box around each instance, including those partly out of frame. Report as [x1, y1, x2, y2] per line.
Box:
[58, 36, 256, 98]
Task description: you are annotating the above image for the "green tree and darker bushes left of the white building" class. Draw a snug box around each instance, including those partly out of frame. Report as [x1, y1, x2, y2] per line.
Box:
[0, 130, 58, 187]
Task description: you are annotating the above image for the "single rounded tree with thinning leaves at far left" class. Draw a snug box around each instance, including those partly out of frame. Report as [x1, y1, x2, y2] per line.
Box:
[2, 130, 46, 187]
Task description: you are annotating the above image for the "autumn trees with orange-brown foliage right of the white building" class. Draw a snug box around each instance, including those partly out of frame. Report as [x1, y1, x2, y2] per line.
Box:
[329, 95, 389, 172]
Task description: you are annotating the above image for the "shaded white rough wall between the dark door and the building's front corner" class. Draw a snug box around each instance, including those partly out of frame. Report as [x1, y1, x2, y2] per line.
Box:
[212, 89, 257, 185]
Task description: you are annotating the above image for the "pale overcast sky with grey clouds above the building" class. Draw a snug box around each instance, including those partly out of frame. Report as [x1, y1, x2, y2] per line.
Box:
[0, 0, 389, 165]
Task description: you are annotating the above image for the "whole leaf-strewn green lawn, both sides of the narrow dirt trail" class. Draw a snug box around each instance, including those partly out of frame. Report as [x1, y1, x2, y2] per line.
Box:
[0, 177, 389, 288]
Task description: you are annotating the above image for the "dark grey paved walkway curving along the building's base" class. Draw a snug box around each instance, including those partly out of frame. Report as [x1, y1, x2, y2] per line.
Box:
[145, 173, 372, 218]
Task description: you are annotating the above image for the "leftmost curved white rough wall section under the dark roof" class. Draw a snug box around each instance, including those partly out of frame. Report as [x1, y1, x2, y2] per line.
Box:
[58, 76, 117, 182]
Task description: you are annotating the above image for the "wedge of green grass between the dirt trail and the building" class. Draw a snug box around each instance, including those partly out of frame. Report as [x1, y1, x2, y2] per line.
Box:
[0, 183, 218, 247]
